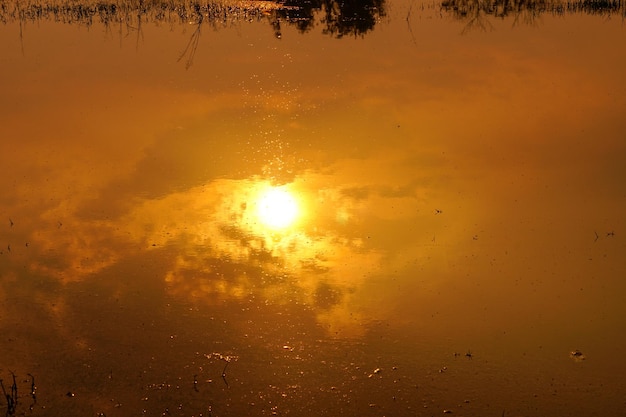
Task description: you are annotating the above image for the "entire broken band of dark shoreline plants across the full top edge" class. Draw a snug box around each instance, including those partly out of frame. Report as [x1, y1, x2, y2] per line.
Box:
[0, 0, 626, 68]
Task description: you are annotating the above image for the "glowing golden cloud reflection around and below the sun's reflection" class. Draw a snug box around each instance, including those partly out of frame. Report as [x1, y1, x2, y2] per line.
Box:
[123, 172, 402, 336]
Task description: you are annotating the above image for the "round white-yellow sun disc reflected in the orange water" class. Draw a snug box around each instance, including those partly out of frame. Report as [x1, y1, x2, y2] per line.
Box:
[258, 188, 298, 229]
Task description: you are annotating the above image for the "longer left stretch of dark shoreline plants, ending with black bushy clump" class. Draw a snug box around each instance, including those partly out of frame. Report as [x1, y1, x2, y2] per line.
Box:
[0, 0, 385, 37]
